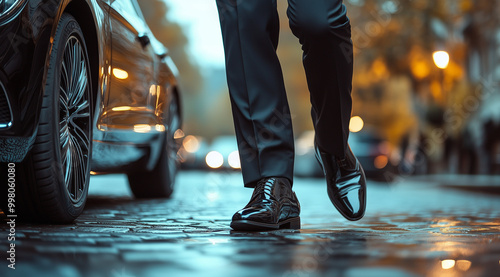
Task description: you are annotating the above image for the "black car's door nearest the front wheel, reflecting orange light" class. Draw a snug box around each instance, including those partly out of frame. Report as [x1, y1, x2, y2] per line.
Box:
[101, 0, 160, 130]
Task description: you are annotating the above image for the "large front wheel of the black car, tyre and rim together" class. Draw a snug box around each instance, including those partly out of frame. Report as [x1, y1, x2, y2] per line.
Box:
[17, 14, 92, 223]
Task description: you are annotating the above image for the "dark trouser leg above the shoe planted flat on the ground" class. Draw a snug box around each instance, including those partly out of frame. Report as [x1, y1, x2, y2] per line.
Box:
[217, 0, 294, 187]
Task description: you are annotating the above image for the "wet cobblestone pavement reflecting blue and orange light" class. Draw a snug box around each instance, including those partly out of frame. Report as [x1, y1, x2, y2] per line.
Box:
[0, 172, 500, 277]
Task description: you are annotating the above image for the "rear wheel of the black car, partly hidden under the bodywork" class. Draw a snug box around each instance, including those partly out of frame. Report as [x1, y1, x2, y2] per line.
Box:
[128, 93, 181, 198]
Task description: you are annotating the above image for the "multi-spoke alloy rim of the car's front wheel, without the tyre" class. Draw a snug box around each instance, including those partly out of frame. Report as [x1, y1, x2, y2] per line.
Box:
[59, 36, 91, 203]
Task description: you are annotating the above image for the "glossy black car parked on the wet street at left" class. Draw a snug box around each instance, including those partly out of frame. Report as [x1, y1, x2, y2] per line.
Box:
[0, 0, 182, 222]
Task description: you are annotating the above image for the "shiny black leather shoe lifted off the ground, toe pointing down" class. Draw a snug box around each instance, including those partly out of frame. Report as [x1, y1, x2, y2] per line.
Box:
[315, 143, 366, 221]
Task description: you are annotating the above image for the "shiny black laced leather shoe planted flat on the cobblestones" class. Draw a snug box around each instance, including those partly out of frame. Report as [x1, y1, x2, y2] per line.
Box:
[231, 178, 300, 231]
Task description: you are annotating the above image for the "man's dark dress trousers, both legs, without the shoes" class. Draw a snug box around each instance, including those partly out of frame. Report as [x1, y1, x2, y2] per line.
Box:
[216, 0, 353, 187]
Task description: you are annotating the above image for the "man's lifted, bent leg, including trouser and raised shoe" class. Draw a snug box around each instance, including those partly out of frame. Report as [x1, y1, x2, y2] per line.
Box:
[288, 0, 366, 220]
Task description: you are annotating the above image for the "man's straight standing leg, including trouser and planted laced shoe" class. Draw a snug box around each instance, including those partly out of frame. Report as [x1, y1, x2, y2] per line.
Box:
[217, 0, 300, 231]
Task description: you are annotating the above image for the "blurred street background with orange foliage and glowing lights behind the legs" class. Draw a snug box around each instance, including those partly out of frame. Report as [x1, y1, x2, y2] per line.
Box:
[138, 0, 500, 180]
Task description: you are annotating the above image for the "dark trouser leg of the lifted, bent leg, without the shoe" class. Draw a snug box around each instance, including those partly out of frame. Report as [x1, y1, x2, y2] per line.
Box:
[288, 0, 353, 157]
